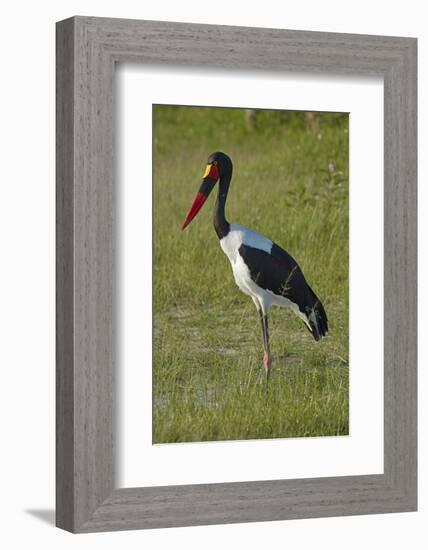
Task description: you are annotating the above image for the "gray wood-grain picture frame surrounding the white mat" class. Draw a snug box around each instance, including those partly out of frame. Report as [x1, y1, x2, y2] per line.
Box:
[56, 17, 417, 532]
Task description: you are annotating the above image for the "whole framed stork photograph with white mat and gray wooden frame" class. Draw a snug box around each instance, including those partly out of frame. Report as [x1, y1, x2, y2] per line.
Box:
[56, 17, 417, 533]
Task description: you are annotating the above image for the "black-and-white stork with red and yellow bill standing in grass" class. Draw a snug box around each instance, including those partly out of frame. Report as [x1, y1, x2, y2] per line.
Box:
[182, 152, 328, 378]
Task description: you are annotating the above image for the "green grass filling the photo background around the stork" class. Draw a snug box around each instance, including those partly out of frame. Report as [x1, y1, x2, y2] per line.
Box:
[153, 106, 349, 443]
